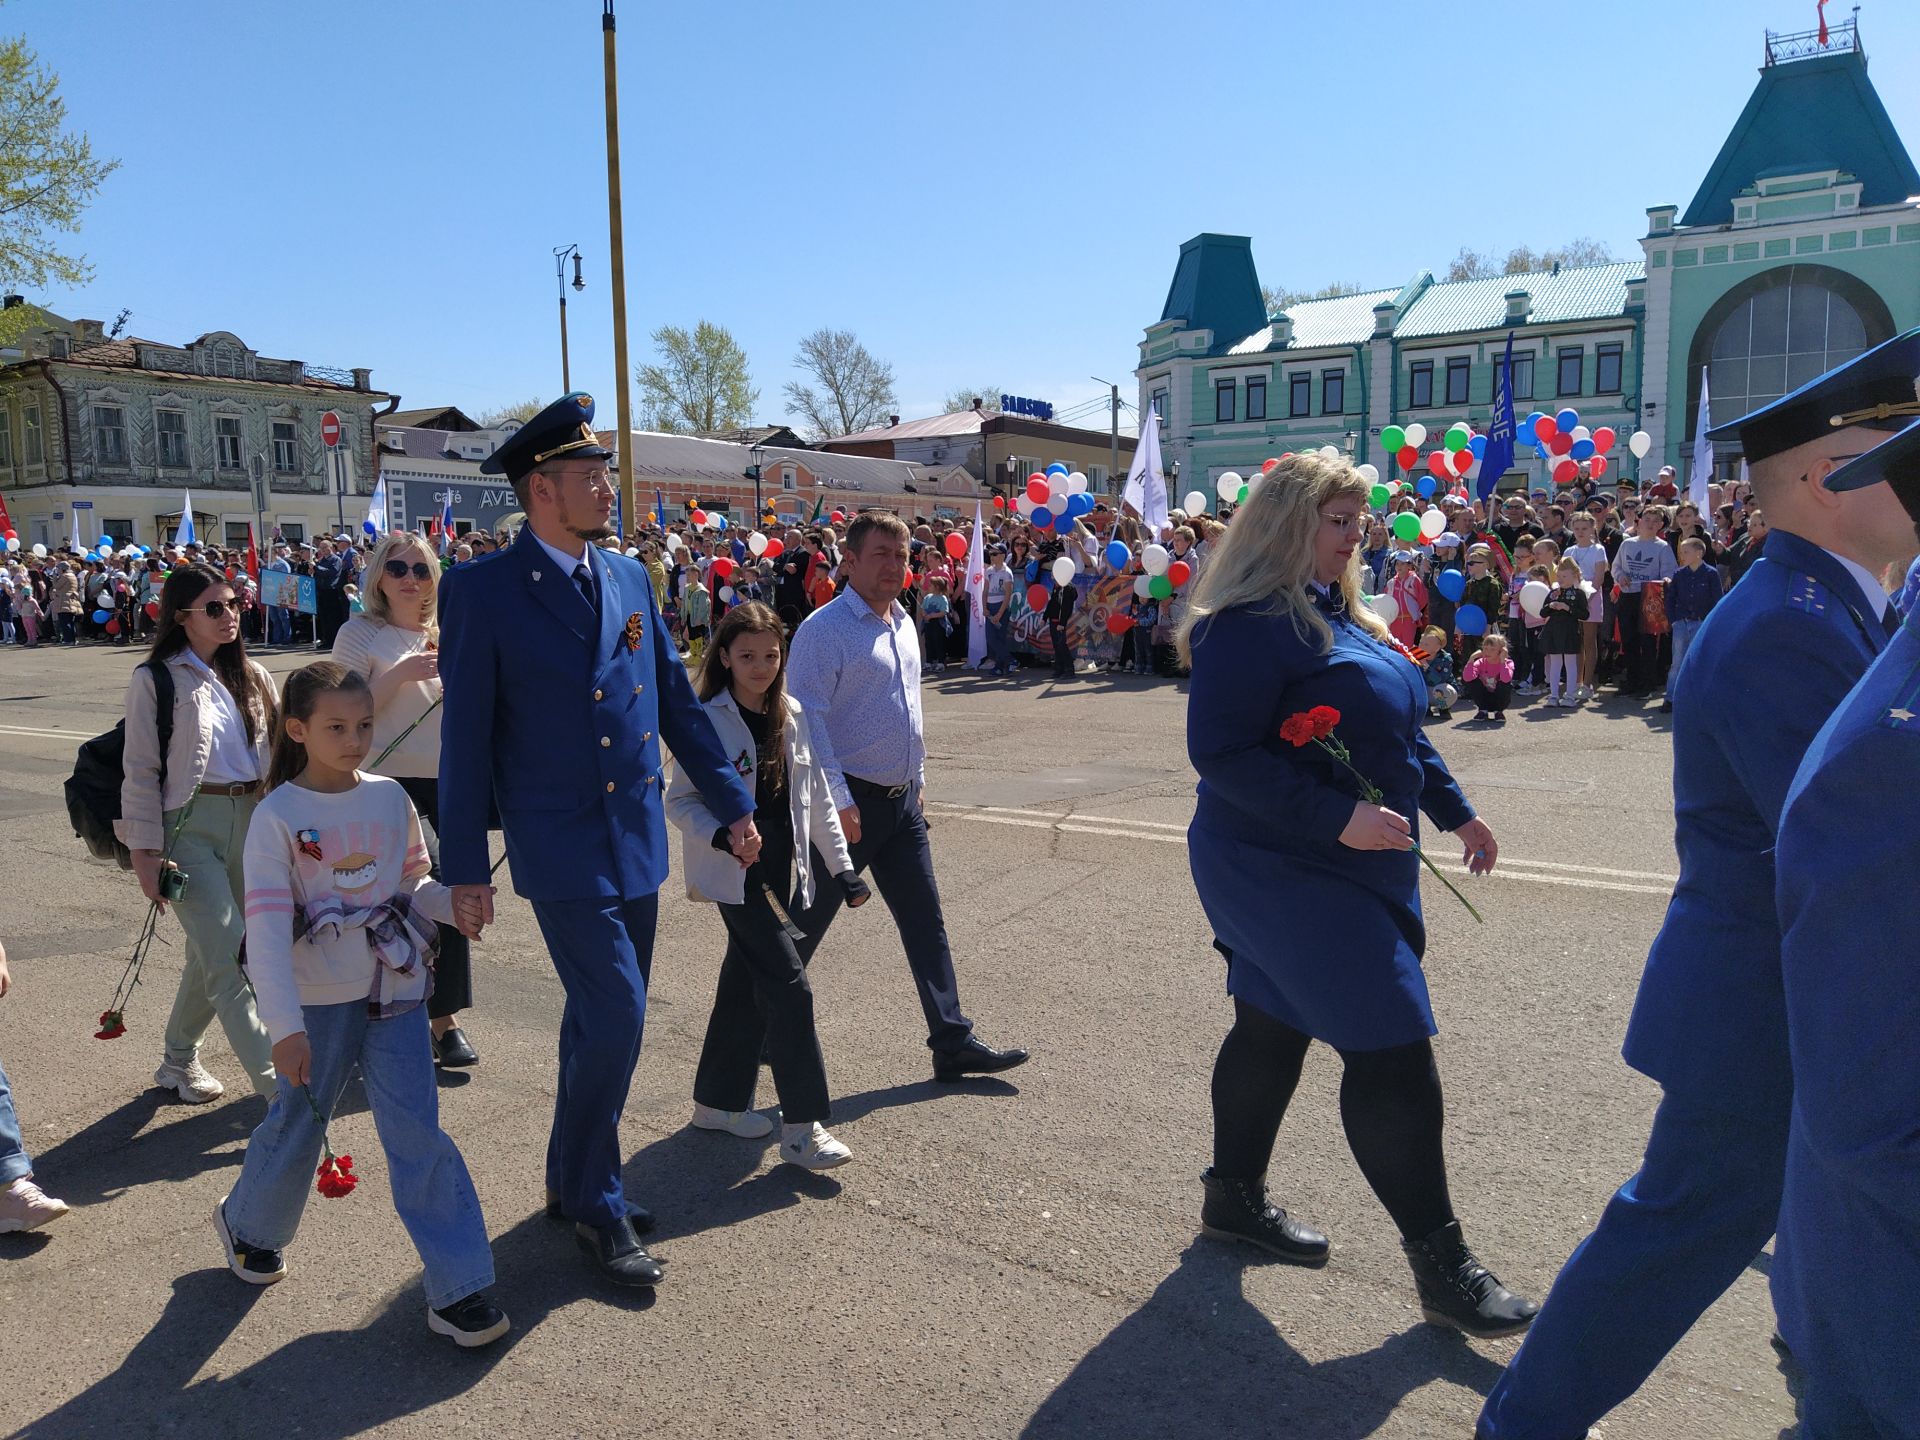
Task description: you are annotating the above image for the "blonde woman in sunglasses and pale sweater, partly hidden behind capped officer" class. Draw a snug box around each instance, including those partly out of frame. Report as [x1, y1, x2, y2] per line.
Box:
[332, 530, 480, 1069]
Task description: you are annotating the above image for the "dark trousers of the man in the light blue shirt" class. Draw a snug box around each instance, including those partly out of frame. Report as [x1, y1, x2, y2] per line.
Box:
[793, 776, 973, 1050]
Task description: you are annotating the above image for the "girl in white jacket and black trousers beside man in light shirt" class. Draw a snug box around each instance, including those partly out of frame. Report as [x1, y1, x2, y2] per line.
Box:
[666, 601, 868, 1169]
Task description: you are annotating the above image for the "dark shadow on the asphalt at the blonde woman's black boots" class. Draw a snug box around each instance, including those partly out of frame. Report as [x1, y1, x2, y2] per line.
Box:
[1023, 1240, 1501, 1440]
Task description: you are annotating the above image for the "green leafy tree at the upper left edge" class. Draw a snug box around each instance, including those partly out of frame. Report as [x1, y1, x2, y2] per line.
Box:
[0, 29, 119, 345]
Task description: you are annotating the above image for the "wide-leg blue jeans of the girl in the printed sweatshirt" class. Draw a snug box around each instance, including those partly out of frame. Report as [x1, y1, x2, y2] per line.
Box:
[225, 1000, 493, 1309]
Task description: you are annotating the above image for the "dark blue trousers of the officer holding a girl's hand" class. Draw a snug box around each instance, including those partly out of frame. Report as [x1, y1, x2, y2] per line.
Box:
[534, 895, 660, 1225]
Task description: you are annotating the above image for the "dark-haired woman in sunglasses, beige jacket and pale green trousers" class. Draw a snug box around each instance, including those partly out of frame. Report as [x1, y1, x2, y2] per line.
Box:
[113, 564, 278, 1104]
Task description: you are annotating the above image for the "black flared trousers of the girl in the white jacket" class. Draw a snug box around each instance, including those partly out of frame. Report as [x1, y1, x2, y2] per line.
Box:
[693, 872, 833, 1125]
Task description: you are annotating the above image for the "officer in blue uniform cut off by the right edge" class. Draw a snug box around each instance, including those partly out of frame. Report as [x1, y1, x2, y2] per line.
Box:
[1772, 420, 1920, 1440]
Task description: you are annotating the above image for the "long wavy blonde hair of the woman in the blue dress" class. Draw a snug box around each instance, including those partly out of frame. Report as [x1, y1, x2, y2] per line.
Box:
[1175, 453, 1388, 664]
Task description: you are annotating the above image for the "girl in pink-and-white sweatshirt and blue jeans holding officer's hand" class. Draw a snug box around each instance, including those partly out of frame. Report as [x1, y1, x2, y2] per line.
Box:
[213, 660, 507, 1348]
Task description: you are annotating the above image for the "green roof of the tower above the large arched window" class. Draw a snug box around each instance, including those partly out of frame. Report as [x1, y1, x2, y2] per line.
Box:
[1680, 50, 1920, 225]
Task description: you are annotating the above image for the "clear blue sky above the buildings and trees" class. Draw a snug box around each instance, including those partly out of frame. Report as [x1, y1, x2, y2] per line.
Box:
[15, 0, 1920, 433]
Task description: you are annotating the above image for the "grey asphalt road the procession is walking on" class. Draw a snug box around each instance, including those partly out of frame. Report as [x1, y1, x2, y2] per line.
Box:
[0, 649, 1791, 1440]
